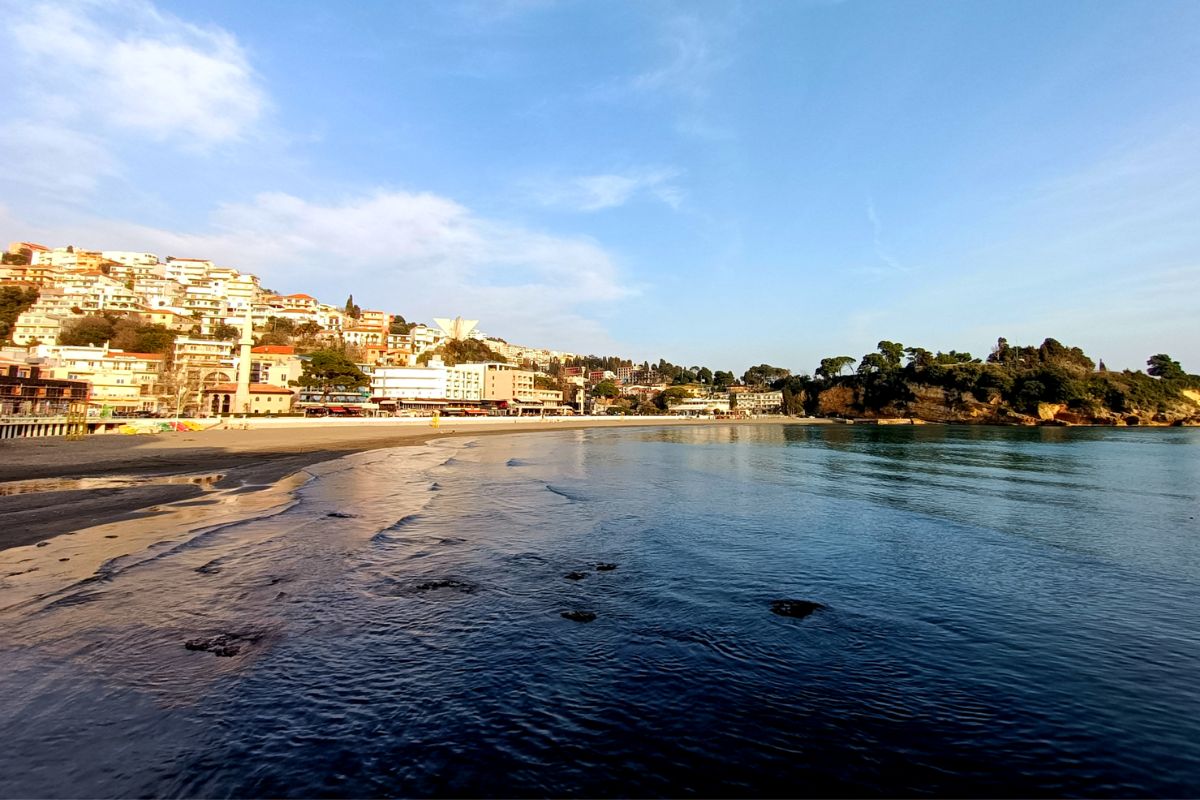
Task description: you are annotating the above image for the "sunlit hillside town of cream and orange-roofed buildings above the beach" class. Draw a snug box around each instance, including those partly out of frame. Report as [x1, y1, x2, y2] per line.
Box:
[0, 242, 782, 432]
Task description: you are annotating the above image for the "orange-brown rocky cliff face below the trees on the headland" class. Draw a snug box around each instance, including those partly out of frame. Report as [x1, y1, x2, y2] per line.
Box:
[817, 384, 1200, 426]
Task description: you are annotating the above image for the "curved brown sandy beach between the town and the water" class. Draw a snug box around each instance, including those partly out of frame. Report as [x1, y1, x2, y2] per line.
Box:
[0, 417, 799, 551]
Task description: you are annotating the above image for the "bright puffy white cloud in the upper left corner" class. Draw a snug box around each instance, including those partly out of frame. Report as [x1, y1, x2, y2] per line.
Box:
[0, 0, 269, 194]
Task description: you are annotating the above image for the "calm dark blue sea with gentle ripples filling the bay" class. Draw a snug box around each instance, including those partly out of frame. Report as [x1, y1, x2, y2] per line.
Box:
[0, 426, 1200, 796]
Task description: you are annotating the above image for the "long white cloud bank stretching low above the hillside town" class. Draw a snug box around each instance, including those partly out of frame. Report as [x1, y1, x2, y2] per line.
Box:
[0, 191, 635, 348]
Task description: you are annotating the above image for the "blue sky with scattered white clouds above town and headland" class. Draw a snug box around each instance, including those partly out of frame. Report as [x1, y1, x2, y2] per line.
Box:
[0, 0, 1200, 372]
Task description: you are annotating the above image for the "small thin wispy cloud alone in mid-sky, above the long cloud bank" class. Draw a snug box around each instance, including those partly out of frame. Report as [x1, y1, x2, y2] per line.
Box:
[528, 167, 683, 211]
